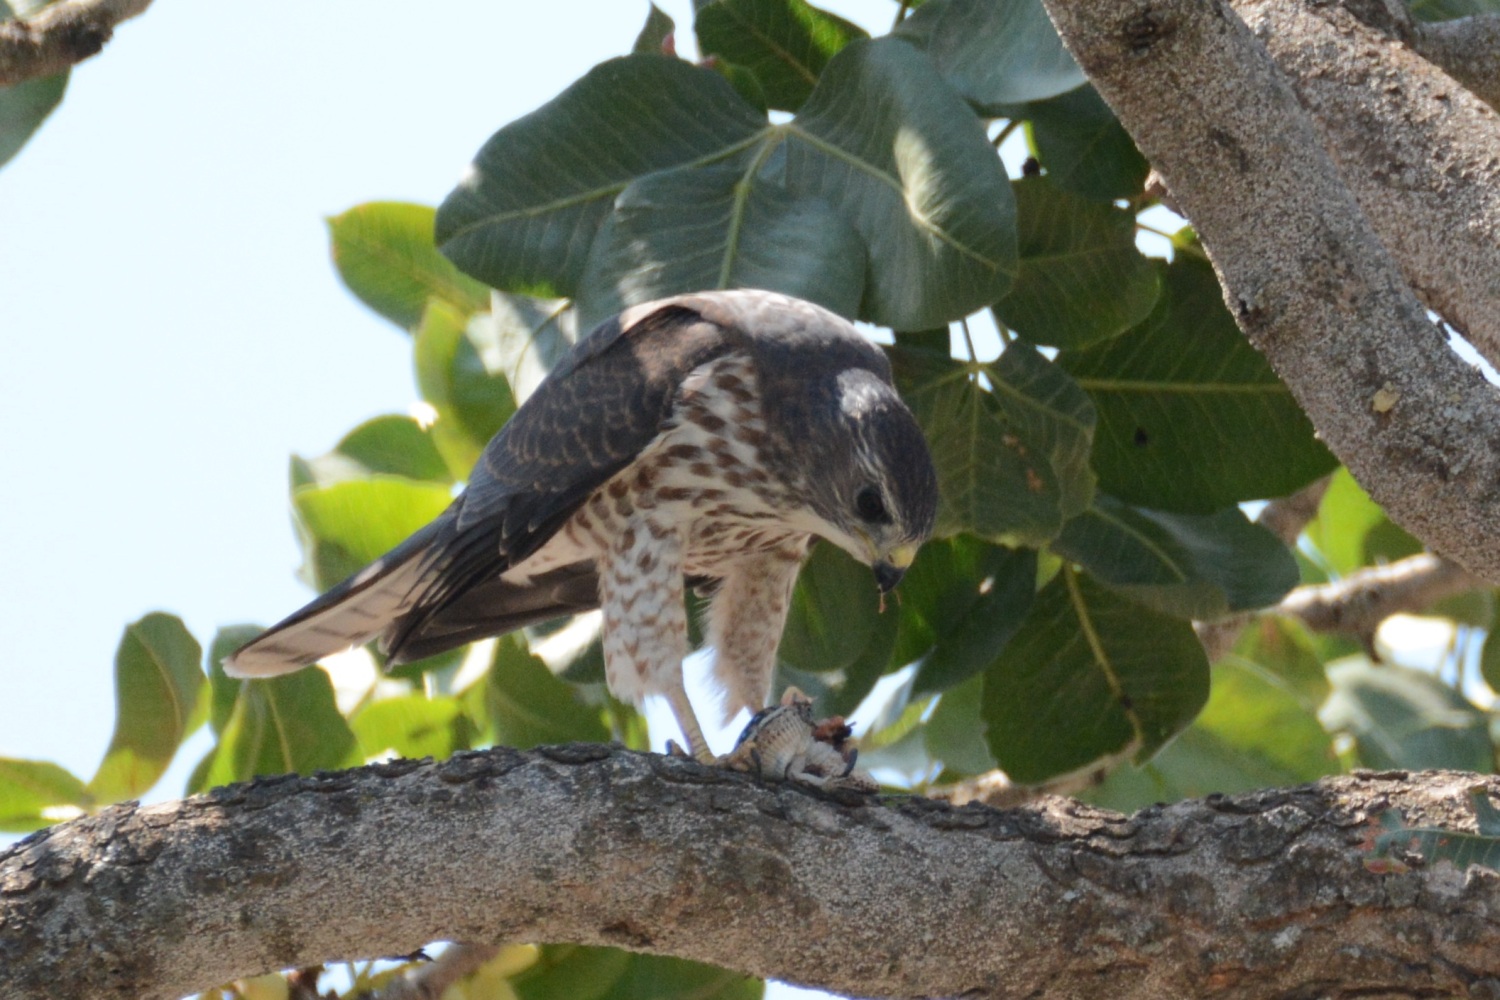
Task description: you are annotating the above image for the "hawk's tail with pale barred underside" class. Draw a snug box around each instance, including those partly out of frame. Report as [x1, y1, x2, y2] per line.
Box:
[224, 526, 432, 678]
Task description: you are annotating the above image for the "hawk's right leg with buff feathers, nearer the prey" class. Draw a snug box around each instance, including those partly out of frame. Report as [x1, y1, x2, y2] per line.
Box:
[708, 535, 807, 720]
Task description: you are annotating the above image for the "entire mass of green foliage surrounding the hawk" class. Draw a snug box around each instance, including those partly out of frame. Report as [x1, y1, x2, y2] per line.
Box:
[0, 0, 1500, 997]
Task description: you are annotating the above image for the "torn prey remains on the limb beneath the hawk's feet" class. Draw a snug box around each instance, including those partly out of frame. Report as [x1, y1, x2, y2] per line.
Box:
[719, 688, 881, 792]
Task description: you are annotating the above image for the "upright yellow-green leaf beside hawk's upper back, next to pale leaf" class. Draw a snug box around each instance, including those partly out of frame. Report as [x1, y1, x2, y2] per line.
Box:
[413, 300, 516, 478]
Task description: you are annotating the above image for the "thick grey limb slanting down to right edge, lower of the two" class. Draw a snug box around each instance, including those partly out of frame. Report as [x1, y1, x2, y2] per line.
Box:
[1046, 0, 1500, 580]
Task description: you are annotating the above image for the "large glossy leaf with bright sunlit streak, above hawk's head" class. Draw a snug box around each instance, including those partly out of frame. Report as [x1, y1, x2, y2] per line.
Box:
[783, 39, 1016, 330]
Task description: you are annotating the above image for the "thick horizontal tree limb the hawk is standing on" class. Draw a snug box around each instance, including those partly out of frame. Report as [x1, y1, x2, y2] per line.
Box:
[0, 745, 1500, 1000]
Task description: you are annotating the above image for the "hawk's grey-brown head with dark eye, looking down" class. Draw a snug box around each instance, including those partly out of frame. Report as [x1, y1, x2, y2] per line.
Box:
[804, 367, 938, 591]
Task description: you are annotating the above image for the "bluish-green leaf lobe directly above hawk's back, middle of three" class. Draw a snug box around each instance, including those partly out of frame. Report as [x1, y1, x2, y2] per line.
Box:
[578, 158, 866, 327]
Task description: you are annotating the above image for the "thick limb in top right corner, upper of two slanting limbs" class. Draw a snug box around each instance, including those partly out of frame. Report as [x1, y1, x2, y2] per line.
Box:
[1232, 0, 1500, 364]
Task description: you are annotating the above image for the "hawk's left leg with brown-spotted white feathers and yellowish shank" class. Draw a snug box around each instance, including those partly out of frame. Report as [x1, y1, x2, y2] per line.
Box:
[599, 515, 714, 762]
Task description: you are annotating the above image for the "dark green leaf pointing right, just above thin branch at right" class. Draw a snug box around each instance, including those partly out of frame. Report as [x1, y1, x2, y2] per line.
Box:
[1052, 493, 1298, 619]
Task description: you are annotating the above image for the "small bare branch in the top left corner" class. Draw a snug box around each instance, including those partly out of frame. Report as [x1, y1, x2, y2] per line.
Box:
[0, 0, 152, 87]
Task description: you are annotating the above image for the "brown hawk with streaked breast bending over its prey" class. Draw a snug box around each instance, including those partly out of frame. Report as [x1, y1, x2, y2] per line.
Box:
[224, 291, 938, 760]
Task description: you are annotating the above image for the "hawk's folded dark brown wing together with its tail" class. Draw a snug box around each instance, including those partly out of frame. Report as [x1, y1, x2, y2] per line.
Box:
[225, 295, 732, 676]
